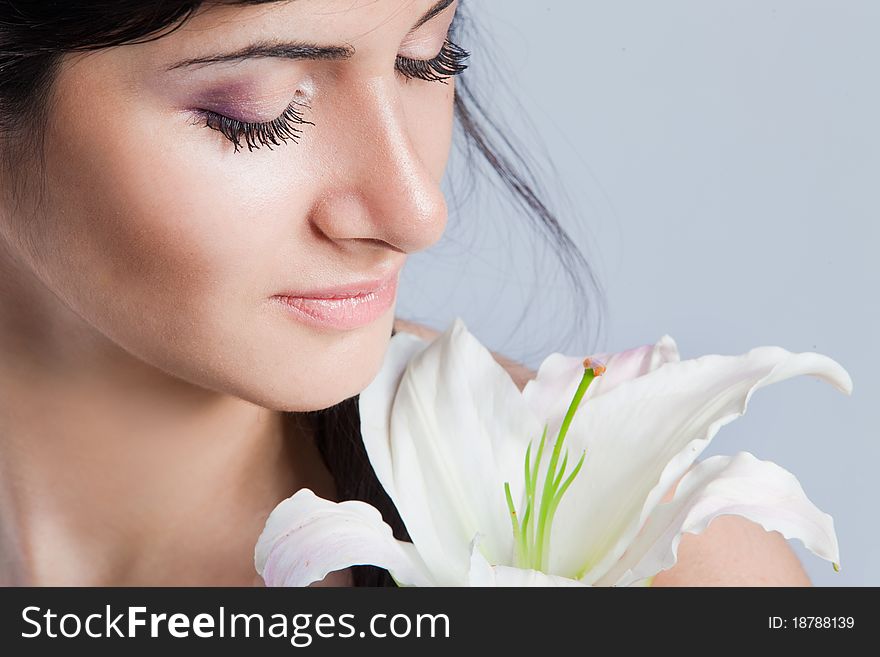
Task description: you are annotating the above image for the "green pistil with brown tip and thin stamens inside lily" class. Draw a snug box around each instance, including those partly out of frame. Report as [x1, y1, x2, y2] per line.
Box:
[504, 360, 605, 572]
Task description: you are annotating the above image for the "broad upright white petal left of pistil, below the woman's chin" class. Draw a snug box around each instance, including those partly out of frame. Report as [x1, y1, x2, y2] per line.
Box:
[360, 319, 542, 584]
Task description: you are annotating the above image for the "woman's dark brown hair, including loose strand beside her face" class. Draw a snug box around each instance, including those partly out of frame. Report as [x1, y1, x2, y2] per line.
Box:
[0, 0, 601, 586]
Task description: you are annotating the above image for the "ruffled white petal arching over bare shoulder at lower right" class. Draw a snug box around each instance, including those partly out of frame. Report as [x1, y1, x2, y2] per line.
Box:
[597, 452, 840, 586]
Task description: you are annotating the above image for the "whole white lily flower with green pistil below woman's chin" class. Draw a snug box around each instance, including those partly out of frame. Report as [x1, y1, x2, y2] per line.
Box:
[254, 319, 852, 586]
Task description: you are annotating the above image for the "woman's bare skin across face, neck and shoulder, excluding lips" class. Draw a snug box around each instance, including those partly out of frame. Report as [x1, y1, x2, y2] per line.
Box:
[0, 0, 808, 586]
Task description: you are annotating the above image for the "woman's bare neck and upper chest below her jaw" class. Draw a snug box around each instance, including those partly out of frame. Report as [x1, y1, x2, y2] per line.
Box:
[0, 256, 332, 586]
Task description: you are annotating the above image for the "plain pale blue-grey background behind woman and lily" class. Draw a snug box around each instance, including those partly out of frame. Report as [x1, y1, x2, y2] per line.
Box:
[398, 0, 880, 586]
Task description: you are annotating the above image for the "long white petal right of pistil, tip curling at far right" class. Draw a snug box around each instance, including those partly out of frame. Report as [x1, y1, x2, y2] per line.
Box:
[549, 347, 852, 584]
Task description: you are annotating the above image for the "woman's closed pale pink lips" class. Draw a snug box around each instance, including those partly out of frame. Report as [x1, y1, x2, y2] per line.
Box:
[272, 267, 400, 330]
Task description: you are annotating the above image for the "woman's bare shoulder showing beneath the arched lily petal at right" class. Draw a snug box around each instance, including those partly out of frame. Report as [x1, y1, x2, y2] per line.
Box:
[652, 468, 812, 586]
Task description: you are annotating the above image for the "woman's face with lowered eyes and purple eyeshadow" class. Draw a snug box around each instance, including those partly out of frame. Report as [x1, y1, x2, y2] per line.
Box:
[2, 0, 458, 410]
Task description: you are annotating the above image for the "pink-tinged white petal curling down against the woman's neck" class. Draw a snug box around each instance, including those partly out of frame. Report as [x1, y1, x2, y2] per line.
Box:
[254, 488, 433, 586]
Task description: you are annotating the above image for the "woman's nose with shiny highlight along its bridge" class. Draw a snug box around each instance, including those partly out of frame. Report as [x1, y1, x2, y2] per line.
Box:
[310, 76, 448, 253]
